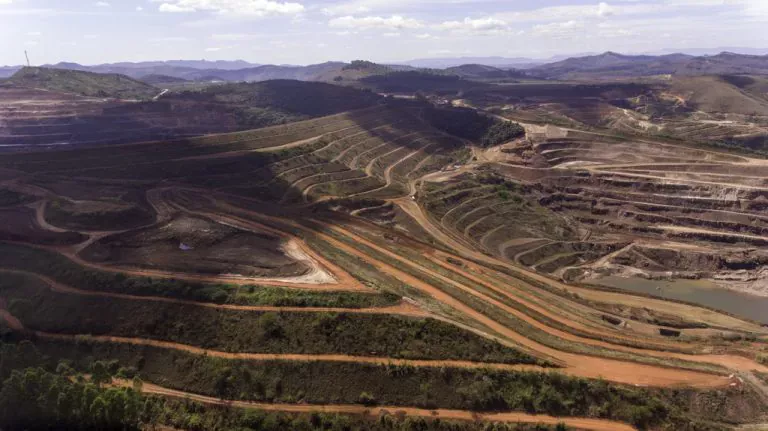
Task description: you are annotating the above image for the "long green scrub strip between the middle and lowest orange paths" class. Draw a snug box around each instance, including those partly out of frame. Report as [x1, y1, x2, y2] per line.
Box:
[3, 339, 722, 431]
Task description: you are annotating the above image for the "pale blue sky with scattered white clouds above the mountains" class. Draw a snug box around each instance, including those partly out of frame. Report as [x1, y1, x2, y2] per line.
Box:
[0, 0, 768, 65]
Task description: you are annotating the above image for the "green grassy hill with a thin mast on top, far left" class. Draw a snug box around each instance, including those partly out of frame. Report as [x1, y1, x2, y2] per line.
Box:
[9, 67, 159, 99]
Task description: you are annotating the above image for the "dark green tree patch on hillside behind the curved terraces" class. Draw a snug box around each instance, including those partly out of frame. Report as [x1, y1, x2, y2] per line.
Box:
[424, 107, 525, 147]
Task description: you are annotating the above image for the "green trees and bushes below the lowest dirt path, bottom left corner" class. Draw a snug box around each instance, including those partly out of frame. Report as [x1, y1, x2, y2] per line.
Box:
[0, 342, 564, 431]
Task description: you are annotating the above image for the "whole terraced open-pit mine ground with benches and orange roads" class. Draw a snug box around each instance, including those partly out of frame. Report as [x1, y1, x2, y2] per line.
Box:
[0, 82, 768, 430]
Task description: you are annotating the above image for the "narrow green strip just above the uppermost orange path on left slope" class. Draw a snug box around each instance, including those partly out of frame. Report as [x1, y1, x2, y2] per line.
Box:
[0, 243, 399, 308]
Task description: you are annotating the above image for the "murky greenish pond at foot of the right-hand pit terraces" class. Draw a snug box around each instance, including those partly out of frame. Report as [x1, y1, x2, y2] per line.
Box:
[593, 276, 768, 324]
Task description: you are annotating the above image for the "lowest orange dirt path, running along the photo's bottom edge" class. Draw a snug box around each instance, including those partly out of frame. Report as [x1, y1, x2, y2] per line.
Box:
[113, 379, 635, 431]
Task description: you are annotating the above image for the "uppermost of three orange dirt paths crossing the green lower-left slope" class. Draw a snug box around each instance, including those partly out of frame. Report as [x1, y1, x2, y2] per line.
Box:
[0, 268, 420, 317]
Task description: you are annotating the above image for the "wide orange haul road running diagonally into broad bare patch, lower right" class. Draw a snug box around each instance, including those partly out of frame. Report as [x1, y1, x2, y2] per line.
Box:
[192, 196, 730, 388]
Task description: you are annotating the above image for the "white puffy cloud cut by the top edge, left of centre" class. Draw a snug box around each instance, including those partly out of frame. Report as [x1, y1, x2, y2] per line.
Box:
[152, 0, 304, 16]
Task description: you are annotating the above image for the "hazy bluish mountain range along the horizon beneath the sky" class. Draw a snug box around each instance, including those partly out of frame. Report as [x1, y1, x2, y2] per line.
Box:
[0, 52, 768, 85]
